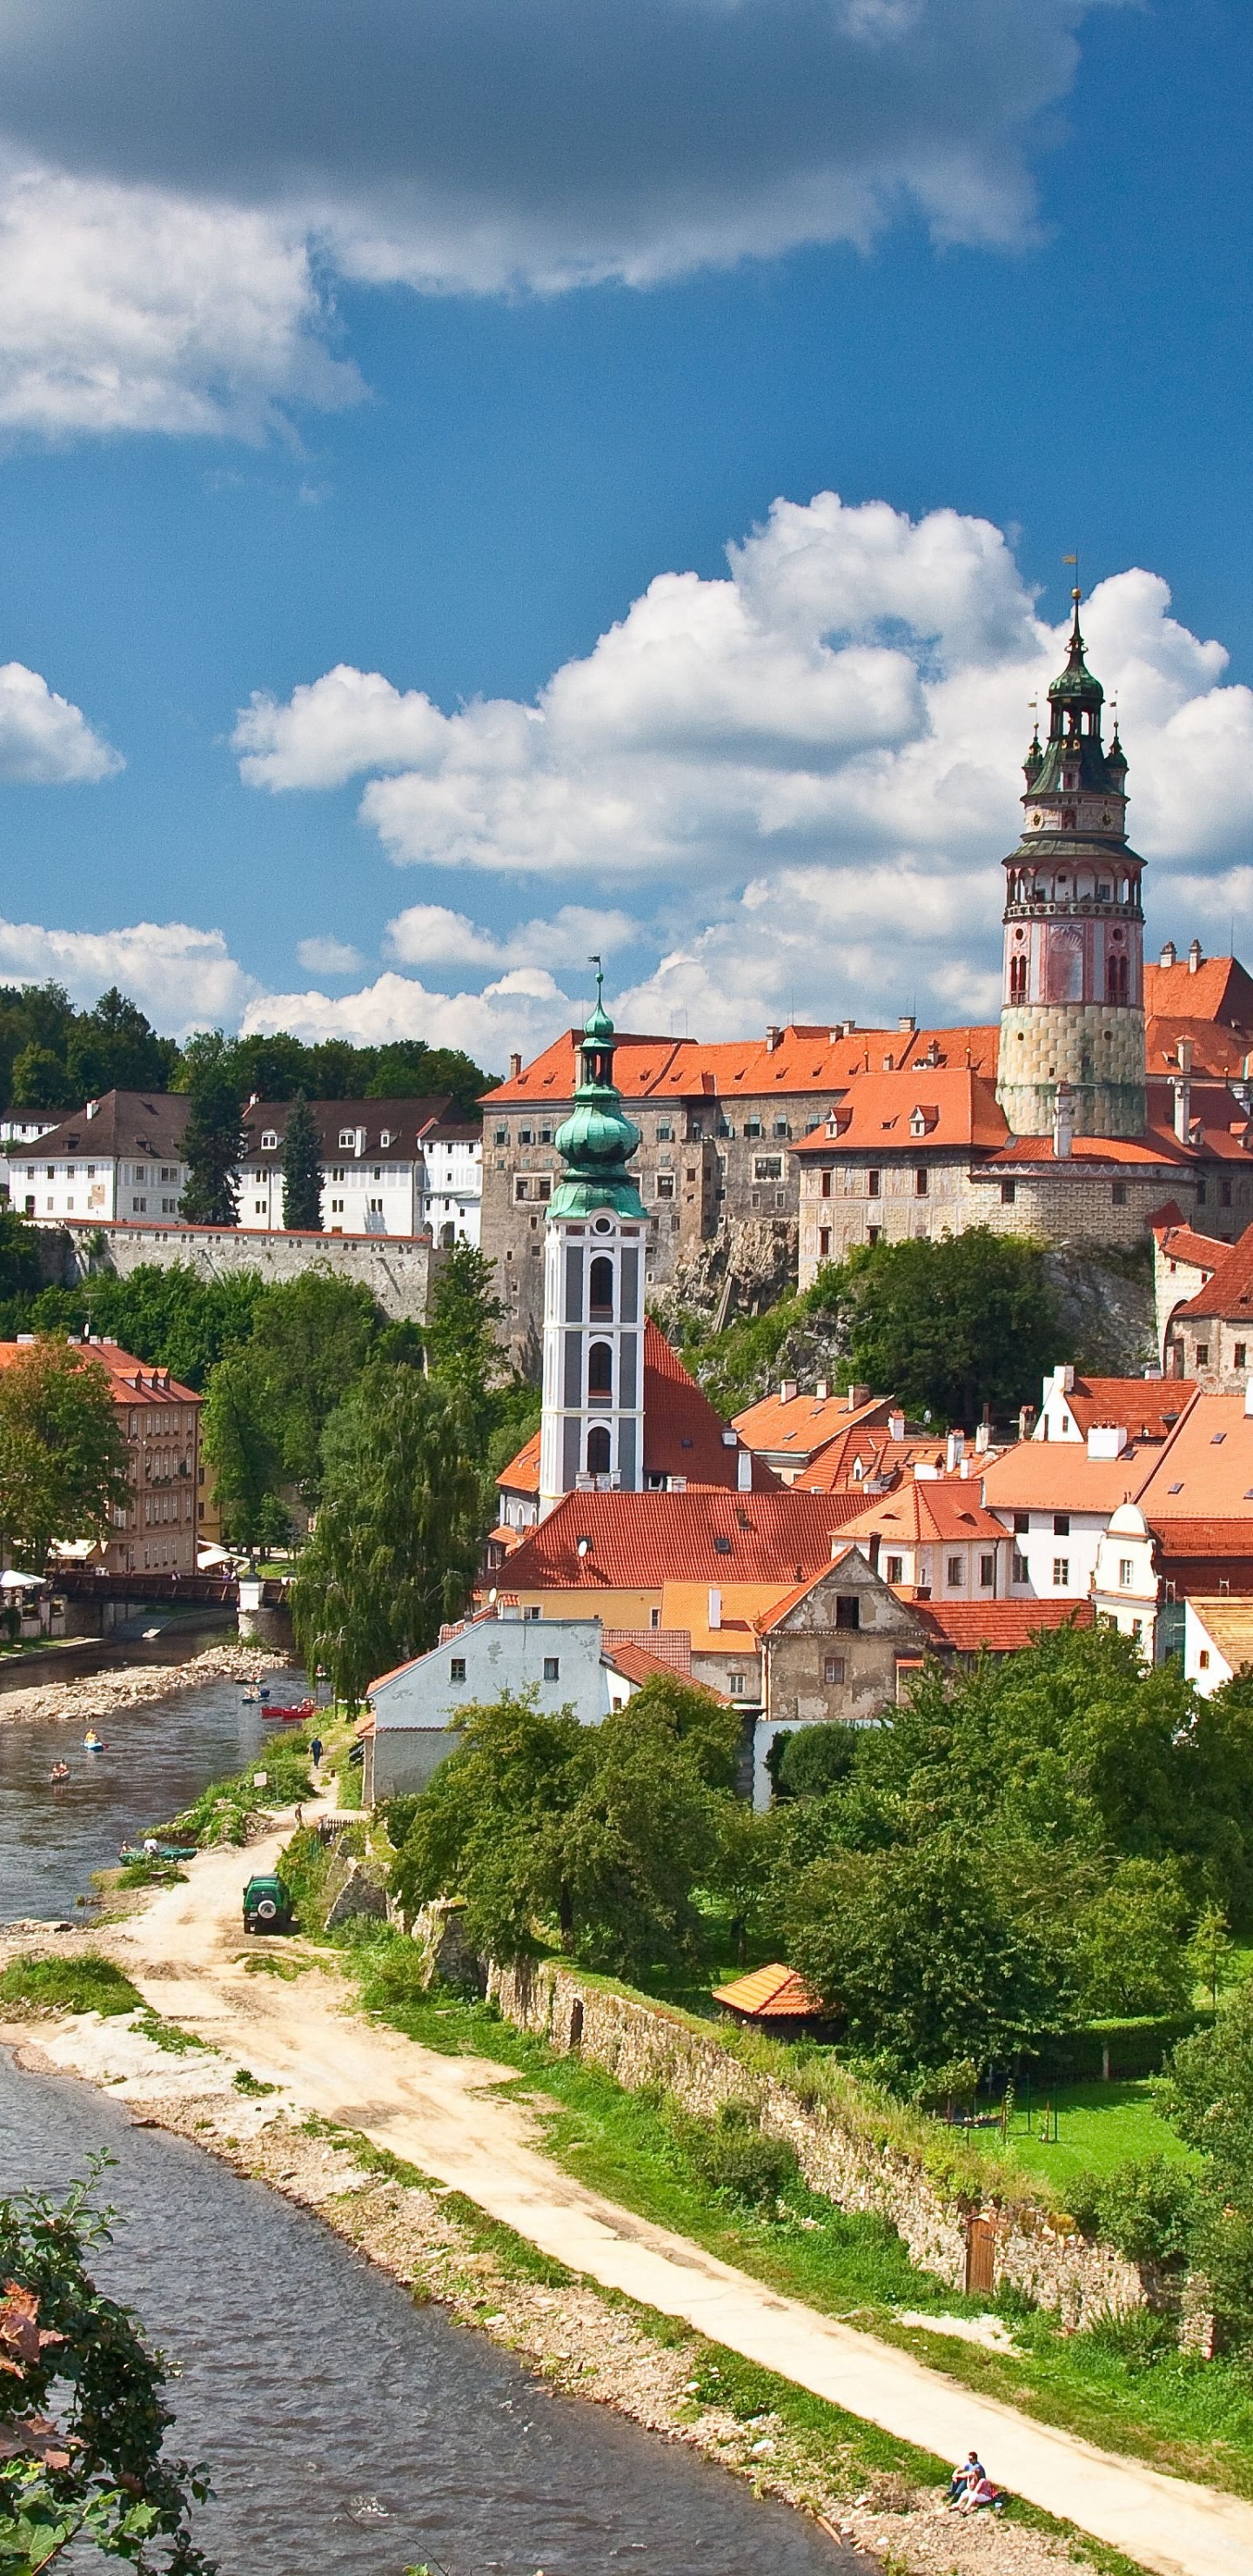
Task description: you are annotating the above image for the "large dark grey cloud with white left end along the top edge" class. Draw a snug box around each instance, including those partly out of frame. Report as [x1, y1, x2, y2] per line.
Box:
[0, 0, 1109, 435]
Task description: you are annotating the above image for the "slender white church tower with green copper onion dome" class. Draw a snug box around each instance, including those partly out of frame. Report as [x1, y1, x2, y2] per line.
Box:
[539, 958, 647, 1513]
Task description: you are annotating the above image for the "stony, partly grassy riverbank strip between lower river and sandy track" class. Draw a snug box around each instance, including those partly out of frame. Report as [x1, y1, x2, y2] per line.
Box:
[0, 2009, 1129, 2576]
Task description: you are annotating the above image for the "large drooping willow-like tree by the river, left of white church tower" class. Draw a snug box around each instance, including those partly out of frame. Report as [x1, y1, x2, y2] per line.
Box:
[291, 1363, 487, 1707]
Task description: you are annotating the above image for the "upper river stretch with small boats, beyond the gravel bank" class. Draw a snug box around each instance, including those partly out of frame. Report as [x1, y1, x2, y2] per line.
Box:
[0, 1667, 305, 1922]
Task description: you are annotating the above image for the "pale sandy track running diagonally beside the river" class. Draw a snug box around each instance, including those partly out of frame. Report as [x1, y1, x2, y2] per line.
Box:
[95, 1835, 1253, 2576]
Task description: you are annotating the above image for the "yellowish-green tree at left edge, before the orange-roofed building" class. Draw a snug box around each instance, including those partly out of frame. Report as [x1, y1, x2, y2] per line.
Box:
[0, 1337, 131, 1574]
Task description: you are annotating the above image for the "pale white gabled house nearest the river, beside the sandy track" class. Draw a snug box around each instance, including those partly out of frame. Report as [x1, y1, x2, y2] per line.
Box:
[364, 1602, 632, 1806]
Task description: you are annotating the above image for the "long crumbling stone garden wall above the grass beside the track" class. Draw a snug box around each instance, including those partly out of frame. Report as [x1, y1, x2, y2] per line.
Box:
[487, 1961, 1148, 2326]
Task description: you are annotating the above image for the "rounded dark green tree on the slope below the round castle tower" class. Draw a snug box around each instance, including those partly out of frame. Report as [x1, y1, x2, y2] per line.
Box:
[841, 1226, 1057, 1422]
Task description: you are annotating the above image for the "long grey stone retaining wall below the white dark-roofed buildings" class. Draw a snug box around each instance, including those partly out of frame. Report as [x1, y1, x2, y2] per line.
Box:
[41, 1224, 446, 1324]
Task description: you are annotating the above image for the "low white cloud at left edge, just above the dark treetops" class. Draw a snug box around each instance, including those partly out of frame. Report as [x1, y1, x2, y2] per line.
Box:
[0, 920, 258, 1038]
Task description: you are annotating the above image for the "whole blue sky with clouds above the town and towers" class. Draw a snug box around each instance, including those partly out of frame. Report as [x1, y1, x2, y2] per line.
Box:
[0, 0, 1253, 1063]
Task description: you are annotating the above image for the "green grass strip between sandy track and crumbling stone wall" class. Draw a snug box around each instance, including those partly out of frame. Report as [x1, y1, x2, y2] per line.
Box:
[335, 1929, 1253, 2496]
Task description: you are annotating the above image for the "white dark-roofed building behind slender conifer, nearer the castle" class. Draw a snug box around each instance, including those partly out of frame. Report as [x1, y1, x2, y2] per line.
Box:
[240, 1095, 482, 1244]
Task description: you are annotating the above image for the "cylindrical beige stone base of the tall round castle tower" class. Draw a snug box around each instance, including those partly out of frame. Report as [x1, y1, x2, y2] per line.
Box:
[995, 1002, 1148, 1136]
